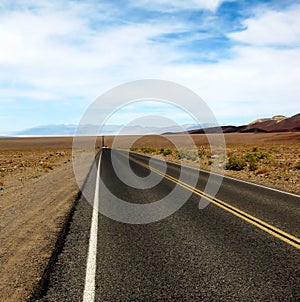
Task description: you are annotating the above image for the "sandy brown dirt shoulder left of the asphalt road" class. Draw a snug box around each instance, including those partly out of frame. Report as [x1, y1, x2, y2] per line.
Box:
[0, 148, 78, 301]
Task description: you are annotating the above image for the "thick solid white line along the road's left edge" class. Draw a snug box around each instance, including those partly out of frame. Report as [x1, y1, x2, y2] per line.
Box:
[83, 153, 102, 302]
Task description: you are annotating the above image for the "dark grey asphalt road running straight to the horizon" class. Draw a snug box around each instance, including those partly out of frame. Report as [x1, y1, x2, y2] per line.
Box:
[41, 149, 300, 301]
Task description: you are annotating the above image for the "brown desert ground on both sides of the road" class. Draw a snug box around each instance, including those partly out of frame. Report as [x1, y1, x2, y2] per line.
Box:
[0, 132, 300, 301]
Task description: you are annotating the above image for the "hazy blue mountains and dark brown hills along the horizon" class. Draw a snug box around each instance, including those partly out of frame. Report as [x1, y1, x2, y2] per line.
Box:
[11, 113, 300, 136]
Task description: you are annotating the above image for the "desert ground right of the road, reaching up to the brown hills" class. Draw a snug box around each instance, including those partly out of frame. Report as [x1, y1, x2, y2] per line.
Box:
[124, 132, 300, 194]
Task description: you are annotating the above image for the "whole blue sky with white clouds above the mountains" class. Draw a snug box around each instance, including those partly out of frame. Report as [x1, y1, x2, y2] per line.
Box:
[0, 0, 300, 135]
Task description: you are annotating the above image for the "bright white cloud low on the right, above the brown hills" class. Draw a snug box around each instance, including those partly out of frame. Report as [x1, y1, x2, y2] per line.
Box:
[162, 47, 300, 119]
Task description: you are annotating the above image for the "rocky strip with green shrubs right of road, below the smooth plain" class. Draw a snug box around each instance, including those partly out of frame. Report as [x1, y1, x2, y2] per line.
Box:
[131, 144, 300, 195]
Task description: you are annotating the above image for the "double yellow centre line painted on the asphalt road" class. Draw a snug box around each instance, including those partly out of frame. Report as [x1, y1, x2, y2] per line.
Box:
[130, 156, 300, 249]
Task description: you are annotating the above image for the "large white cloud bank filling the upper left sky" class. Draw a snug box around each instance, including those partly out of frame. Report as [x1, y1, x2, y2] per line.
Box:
[0, 4, 183, 97]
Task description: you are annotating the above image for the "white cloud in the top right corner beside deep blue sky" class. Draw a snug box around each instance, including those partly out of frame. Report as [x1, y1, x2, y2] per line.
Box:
[229, 5, 300, 46]
